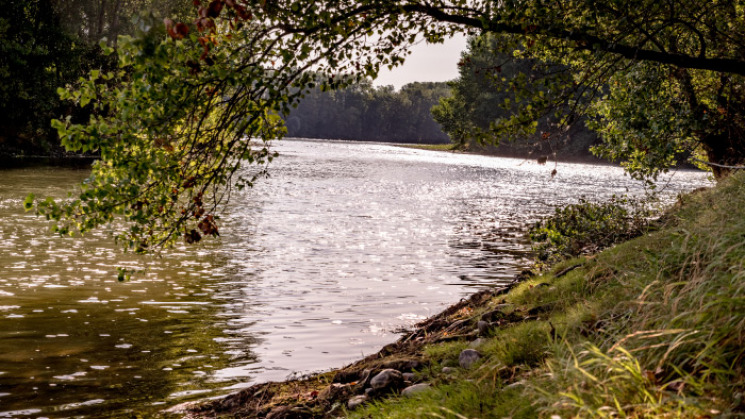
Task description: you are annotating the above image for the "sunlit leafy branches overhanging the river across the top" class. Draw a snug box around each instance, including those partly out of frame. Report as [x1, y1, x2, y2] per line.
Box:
[30, 0, 745, 249]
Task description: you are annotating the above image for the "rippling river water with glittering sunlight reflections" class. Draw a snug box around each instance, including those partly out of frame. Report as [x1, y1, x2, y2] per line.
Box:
[0, 140, 708, 418]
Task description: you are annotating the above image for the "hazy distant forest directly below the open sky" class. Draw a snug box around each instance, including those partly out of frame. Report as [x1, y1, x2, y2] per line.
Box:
[285, 82, 450, 144]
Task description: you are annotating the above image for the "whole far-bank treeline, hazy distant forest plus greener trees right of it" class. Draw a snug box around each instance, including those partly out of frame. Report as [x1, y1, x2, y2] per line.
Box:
[285, 74, 597, 160]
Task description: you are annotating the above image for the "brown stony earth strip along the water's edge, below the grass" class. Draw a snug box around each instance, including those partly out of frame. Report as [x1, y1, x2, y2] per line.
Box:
[174, 280, 530, 419]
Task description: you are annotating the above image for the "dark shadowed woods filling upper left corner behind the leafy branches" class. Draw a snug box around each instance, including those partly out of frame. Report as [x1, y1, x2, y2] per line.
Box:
[0, 0, 192, 155]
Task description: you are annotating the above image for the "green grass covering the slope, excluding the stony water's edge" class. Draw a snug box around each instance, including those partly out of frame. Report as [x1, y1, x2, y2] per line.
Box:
[349, 174, 745, 418]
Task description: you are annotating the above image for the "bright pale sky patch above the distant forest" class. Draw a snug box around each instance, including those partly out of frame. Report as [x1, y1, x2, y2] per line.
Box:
[373, 35, 466, 90]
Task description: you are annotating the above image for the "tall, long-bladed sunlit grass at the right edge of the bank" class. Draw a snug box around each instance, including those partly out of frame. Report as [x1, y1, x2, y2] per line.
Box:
[544, 175, 745, 417]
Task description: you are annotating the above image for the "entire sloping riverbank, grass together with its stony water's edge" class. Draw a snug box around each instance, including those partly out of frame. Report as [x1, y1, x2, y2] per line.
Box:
[181, 174, 745, 418]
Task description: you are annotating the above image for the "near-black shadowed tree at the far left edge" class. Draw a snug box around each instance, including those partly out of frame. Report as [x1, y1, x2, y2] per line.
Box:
[0, 0, 97, 152]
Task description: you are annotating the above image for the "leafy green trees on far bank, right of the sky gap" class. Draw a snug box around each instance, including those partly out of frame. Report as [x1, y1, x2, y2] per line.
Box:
[432, 34, 597, 159]
